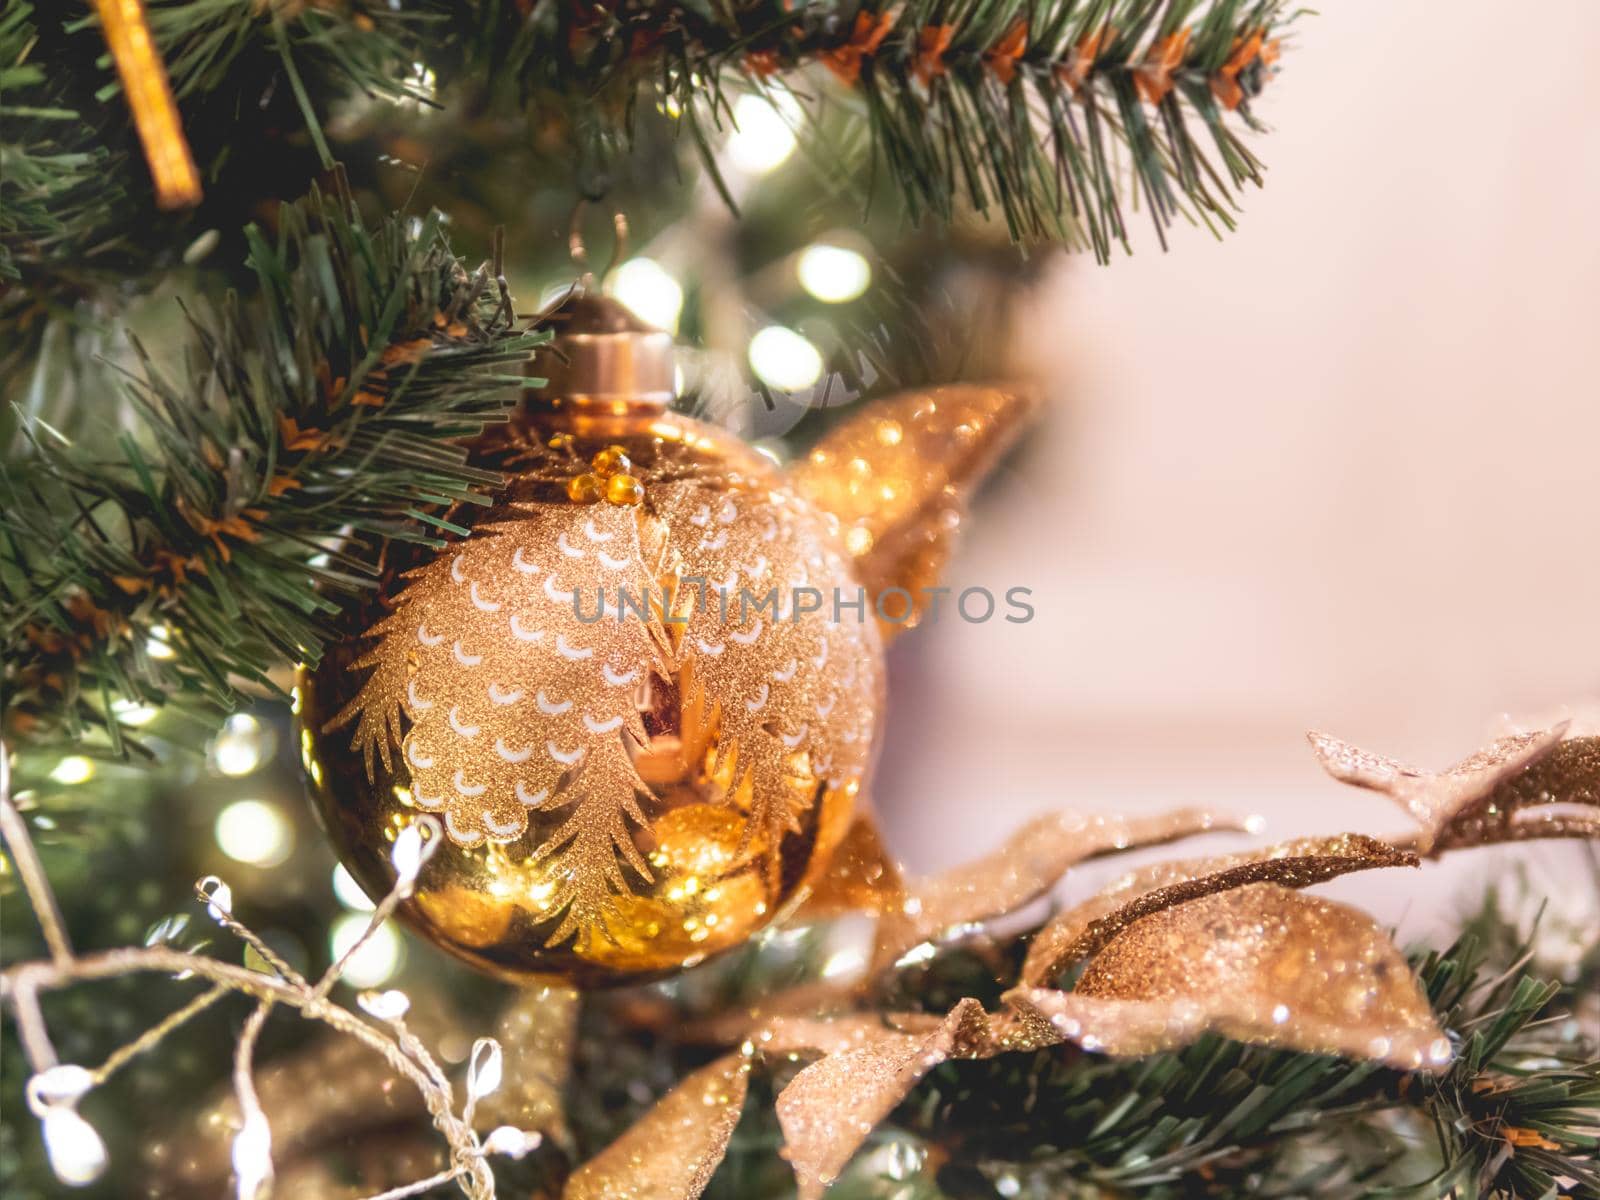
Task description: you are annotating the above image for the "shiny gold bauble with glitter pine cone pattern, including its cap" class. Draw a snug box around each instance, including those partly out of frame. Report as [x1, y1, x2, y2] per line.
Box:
[299, 294, 1030, 986]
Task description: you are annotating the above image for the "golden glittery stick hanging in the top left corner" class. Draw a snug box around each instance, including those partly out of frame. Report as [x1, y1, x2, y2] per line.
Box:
[94, 0, 200, 208]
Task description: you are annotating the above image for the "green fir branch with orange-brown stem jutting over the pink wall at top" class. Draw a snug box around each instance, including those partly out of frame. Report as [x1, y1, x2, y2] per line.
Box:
[457, 0, 1288, 258]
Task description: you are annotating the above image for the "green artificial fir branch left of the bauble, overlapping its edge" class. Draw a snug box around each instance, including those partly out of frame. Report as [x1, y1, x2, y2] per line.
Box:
[0, 178, 544, 744]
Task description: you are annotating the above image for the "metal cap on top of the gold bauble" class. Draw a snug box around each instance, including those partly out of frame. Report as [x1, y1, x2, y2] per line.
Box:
[528, 285, 677, 414]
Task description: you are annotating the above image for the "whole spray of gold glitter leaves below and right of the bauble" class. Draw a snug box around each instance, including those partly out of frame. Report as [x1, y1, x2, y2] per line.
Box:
[565, 713, 1600, 1200]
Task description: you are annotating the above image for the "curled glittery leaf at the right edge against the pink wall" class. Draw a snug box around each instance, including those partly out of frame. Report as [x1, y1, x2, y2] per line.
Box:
[1307, 722, 1600, 858]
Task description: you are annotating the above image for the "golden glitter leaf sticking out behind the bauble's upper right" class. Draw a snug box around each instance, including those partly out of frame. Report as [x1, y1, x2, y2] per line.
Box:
[790, 384, 1035, 635]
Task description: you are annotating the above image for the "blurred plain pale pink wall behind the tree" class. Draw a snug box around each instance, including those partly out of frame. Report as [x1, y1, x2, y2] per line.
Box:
[878, 0, 1600, 931]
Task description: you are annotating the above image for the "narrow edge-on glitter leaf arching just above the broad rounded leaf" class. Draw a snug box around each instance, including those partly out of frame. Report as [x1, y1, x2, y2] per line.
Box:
[1022, 834, 1418, 987]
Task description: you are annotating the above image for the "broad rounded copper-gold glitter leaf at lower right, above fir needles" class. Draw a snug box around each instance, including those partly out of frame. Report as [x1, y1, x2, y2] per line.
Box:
[1006, 883, 1451, 1070]
